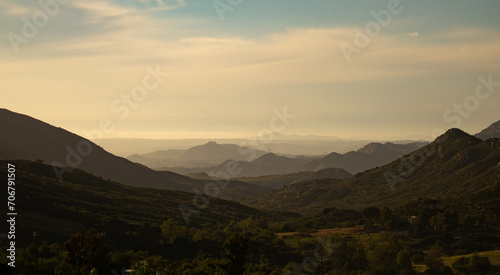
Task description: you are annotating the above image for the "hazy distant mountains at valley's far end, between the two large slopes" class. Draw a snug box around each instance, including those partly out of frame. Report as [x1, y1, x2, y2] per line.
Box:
[132, 142, 427, 177]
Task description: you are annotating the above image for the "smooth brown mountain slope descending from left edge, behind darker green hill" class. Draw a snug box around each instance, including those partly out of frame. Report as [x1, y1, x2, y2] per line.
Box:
[0, 109, 270, 198]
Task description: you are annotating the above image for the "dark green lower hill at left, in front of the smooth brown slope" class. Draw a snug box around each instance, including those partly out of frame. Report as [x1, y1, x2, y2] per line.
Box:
[0, 160, 278, 248]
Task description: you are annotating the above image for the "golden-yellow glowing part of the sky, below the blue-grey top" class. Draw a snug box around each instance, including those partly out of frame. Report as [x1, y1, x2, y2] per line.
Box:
[0, 2, 500, 139]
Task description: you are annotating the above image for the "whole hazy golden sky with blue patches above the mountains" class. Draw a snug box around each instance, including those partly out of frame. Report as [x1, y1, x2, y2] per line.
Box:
[0, 0, 500, 140]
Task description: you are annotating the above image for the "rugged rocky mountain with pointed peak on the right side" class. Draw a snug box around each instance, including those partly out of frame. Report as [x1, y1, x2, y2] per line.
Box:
[248, 129, 500, 213]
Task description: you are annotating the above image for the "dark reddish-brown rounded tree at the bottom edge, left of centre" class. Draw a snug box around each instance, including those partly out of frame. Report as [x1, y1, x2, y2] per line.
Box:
[64, 229, 109, 274]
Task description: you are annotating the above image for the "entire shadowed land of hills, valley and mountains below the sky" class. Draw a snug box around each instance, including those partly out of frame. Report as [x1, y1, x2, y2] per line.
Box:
[0, 110, 500, 274]
